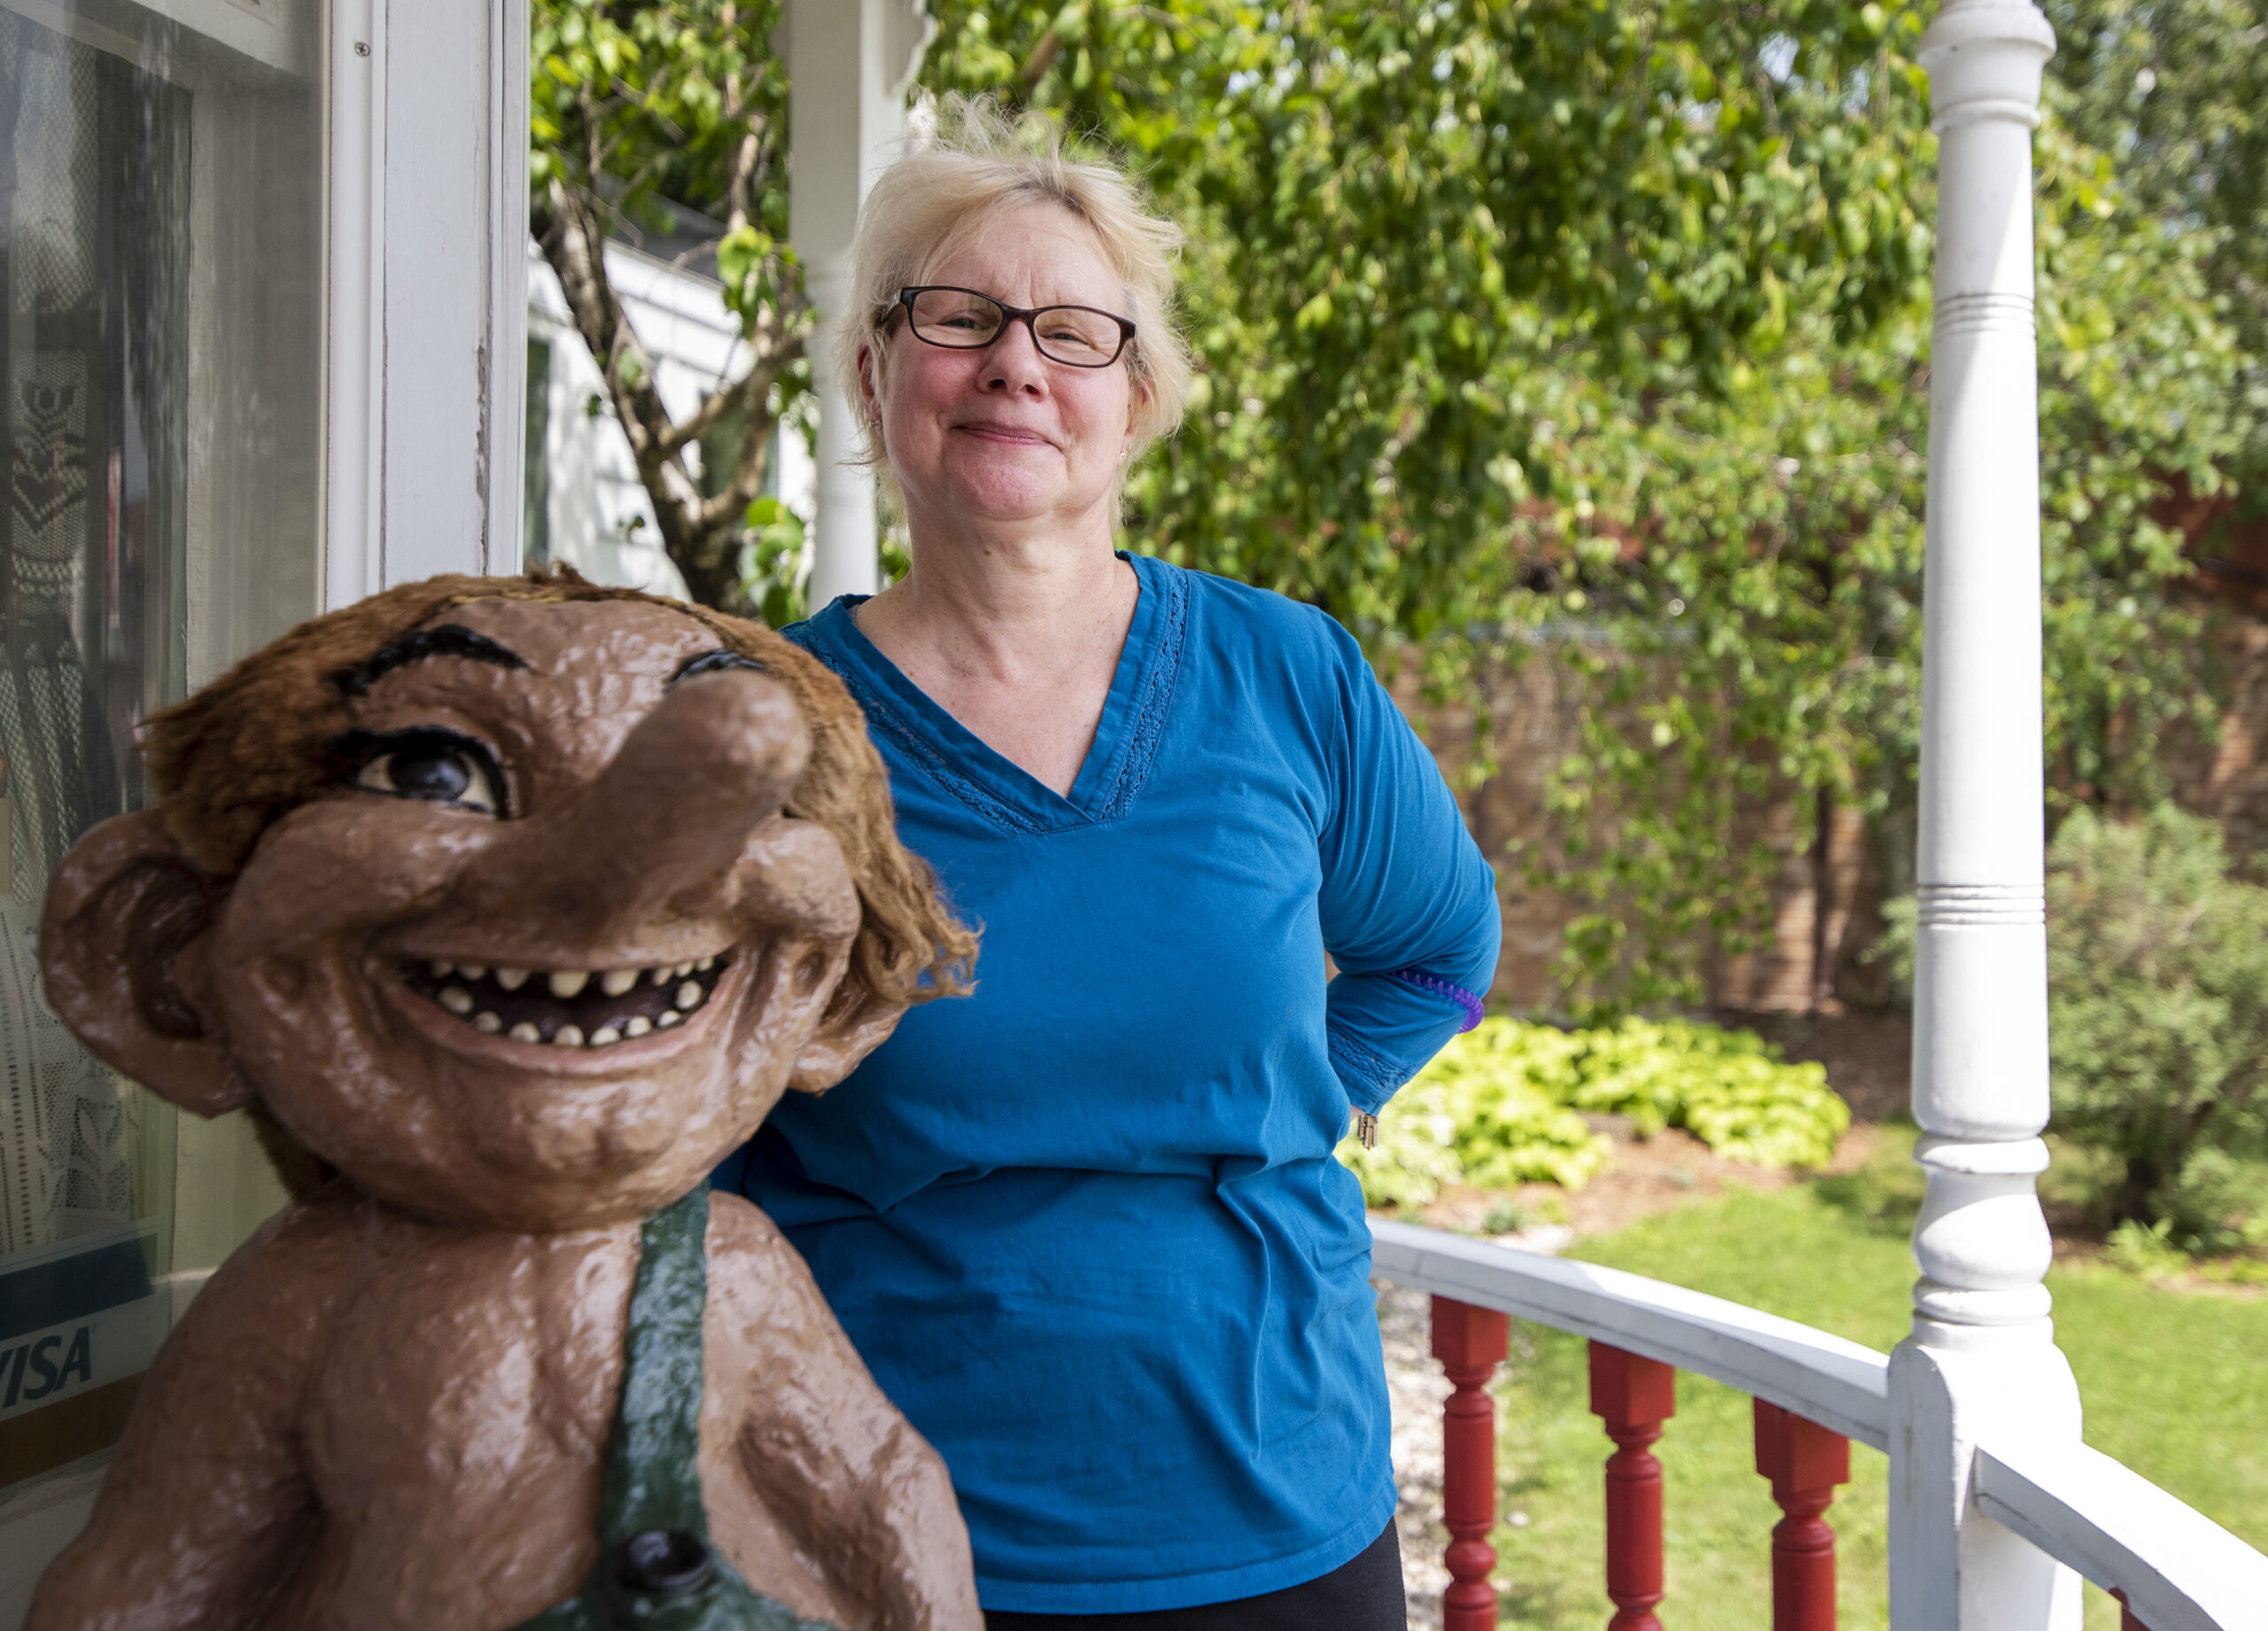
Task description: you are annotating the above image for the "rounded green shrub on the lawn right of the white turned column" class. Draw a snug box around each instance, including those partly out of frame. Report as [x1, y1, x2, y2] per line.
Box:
[2048, 805, 2268, 1247]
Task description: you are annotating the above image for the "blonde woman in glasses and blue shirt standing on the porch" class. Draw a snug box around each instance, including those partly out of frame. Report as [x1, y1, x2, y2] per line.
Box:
[719, 106, 1497, 1631]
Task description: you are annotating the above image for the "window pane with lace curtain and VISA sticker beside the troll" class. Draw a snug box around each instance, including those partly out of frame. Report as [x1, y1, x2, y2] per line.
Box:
[0, 0, 322, 1488]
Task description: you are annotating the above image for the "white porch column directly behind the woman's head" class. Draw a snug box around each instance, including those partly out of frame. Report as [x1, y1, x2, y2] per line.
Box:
[787, 0, 936, 610]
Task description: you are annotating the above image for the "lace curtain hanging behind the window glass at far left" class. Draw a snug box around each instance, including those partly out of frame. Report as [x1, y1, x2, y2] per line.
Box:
[0, 12, 188, 1259]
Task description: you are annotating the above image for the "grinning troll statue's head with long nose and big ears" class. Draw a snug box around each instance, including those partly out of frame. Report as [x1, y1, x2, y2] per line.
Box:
[41, 574, 975, 1231]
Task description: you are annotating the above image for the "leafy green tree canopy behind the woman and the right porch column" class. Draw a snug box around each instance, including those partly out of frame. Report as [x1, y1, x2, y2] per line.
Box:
[923, 0, 2250, 1014]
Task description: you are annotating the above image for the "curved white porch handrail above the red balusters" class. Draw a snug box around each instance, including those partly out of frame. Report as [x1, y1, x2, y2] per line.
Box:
[1372, 1221, 2268, 1631]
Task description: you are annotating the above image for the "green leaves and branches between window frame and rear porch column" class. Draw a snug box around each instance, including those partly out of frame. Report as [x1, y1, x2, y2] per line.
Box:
[528, 0, 810, 617]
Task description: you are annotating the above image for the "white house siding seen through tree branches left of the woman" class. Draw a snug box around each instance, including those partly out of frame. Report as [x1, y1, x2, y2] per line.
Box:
[526, 243, 817, 599]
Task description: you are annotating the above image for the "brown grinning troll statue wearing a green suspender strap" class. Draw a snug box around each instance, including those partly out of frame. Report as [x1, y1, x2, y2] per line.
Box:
[29, 574, 982, 1631]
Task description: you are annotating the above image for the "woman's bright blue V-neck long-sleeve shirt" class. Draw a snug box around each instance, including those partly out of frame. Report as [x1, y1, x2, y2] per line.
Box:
[717, 555, 1497, 1613]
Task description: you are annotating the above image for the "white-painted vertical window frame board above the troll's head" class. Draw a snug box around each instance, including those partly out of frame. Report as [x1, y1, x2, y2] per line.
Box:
[322, 0, 528, 608]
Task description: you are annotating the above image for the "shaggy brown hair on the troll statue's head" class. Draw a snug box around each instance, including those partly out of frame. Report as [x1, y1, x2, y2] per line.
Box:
[143, 567, 977, 1009]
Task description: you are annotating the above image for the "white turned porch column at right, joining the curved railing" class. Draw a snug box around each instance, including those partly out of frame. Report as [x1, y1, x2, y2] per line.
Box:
[1889, 0, 2080, 1631]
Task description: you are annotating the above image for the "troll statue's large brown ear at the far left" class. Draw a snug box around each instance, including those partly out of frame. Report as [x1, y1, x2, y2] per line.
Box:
[39, 810, 250, 1116]
